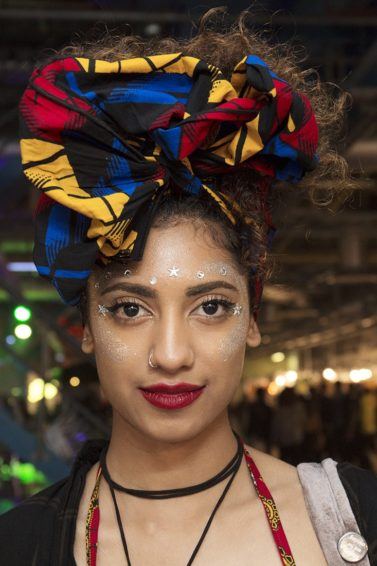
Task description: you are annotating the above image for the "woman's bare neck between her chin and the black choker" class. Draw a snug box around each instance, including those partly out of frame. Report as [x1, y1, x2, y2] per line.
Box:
[106, 413, 237, 490]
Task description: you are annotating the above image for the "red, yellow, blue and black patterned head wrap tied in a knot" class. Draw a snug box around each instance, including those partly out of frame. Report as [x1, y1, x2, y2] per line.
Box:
[20, 53, 318, 304]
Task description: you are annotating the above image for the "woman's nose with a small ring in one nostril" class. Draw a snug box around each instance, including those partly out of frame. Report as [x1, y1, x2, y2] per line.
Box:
[152, 312, 194, 374]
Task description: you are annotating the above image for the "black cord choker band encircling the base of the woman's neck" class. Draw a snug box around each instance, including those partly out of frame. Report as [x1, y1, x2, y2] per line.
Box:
[100, 434, 243, 499]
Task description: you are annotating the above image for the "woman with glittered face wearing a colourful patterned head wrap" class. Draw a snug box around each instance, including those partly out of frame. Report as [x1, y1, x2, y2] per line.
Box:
[0, 8, 377, 566]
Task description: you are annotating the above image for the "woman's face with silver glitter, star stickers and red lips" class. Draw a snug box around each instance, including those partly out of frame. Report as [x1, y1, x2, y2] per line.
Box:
[83, 220, 260, 442]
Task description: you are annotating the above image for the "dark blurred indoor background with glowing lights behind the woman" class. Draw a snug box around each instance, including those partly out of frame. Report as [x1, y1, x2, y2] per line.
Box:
[0, 0, 377, 513]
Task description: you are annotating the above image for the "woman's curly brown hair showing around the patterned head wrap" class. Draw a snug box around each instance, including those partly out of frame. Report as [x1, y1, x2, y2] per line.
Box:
[58, 8, 353, 320]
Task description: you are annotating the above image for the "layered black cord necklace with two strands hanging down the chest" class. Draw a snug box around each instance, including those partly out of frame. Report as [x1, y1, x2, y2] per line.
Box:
[100, 434, 243, 566]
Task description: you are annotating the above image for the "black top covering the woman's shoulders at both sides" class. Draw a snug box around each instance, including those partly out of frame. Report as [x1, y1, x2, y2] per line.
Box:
[0, 440, 377, 566]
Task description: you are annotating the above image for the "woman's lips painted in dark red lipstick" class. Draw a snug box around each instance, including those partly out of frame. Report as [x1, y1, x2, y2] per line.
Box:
[140, 382, 205, 409]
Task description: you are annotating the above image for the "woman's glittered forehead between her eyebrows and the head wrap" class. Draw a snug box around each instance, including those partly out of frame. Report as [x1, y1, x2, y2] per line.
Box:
[92, 220, 240, 279]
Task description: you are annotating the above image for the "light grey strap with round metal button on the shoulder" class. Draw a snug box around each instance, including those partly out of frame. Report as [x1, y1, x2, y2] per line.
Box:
[297, 458, 370, 566]
